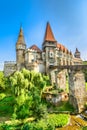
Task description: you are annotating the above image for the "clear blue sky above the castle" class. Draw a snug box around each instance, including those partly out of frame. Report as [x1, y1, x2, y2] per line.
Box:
[0, 0, 87, 70]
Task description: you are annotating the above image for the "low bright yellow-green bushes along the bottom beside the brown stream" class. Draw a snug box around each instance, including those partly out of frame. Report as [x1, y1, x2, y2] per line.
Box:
[22, 114, 69, 130]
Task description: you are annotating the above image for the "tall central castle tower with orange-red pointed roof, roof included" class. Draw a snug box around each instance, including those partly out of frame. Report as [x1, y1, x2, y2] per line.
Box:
[42, 23, 56, 73]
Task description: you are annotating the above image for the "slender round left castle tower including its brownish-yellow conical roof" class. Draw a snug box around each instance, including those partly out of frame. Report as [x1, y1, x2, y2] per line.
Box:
[16, 28, 26, 70]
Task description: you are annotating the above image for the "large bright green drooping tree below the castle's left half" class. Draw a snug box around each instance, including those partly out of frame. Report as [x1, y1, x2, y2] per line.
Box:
[10, 69, 46, 118]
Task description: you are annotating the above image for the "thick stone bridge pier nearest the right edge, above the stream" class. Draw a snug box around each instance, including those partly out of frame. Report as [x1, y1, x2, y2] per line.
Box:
[69, 70, 87, 113]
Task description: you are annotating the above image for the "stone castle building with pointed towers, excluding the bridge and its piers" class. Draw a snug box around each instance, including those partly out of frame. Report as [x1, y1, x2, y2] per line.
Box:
[4, 23, 82, 76]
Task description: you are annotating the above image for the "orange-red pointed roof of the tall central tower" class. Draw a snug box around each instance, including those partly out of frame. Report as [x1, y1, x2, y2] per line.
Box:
[44, 22, 56, 42]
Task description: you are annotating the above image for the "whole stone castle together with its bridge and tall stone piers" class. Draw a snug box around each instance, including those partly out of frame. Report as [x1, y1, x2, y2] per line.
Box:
[4, 23, 87, 112]
